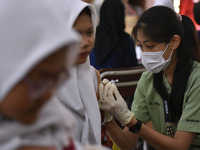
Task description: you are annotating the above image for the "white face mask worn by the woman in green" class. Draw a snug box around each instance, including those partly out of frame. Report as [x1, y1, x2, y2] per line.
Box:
[141, 43, 173, 73]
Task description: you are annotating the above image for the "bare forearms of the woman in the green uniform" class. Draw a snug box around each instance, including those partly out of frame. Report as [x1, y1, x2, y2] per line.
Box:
[106, 118, 194, 150]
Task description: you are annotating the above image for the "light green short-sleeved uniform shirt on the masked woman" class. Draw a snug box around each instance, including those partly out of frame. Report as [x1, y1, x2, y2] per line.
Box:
[132, 62, 200, 150]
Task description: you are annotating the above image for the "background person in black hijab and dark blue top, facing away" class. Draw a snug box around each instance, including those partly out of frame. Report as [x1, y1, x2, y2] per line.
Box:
[90, 0, 138, 70]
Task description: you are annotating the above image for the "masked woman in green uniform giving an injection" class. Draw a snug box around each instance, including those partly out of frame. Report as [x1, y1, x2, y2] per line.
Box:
[99, 6, 200, 150]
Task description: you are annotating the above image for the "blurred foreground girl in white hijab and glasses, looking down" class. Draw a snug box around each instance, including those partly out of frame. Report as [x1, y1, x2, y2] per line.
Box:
[0, 0, 79, 150]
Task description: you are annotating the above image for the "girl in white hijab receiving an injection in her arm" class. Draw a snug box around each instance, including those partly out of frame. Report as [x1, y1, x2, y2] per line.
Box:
[48, 0, 101, 145]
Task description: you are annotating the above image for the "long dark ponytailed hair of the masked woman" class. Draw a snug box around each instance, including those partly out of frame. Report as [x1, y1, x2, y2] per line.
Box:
[132, 6, 200, 122]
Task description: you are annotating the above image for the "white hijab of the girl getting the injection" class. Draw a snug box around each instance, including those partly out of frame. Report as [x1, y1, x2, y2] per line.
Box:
[47, 0, 101, 144]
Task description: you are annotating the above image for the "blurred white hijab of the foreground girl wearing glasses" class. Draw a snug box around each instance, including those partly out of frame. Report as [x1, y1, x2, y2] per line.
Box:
[0, 0, 79, 150]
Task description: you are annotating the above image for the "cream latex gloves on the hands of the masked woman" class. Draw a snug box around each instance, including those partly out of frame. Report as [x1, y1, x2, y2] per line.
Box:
[99, 82, 134, 126]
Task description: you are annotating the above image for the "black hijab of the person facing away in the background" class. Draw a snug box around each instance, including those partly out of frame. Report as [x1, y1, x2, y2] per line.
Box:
[94, 0, 127, 65]
